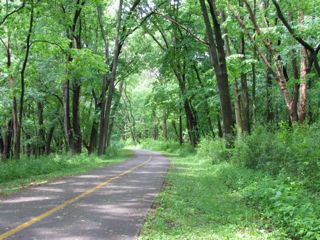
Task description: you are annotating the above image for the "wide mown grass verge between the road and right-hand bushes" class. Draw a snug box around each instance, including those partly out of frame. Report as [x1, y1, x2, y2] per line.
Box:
[140, 151, 285, 240]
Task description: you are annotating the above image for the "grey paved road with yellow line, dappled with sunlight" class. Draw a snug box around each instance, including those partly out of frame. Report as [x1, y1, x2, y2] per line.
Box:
[0, 150, 169, 240]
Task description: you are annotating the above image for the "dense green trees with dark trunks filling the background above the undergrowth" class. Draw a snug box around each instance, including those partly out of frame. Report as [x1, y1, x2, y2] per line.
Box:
[0, 0, 320, 160]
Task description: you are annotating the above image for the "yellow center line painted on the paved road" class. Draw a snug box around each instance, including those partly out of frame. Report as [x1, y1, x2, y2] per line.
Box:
[0, 157, 152, 240]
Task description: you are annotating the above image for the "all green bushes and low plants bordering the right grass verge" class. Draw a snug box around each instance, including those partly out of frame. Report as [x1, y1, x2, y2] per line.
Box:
[197, 124, 320, 240]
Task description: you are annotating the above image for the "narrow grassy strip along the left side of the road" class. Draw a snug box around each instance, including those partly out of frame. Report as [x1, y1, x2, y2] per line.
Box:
[0, 149, 132, 195]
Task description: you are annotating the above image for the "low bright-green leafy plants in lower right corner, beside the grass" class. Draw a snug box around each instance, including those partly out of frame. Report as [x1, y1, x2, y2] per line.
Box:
[219, 164, 320, 240]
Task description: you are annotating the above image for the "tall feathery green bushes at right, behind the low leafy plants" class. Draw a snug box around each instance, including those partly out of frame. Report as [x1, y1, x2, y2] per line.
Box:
[232, 125, 320, 191]
